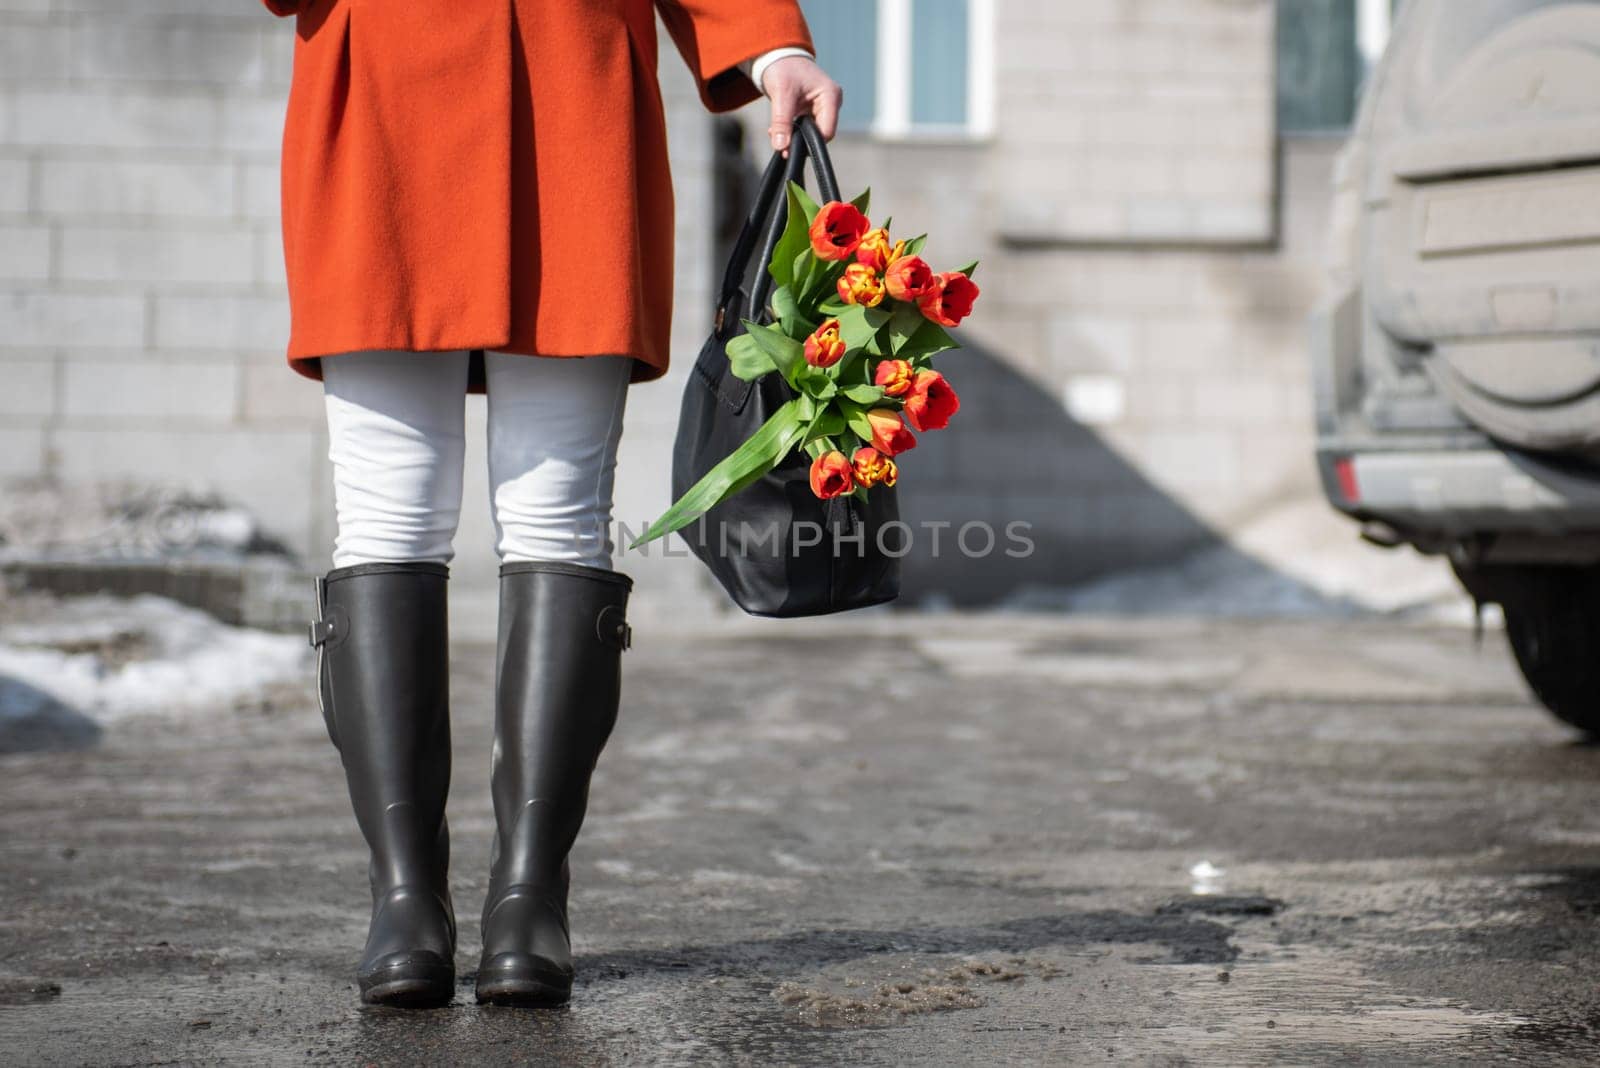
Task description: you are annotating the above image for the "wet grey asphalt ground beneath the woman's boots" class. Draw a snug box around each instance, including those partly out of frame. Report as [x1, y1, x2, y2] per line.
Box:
[0, 614, 1600, 1065]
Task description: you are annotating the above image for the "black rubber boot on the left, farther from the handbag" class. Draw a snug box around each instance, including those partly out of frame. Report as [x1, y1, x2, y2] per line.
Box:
[310, 563, 456, 1007]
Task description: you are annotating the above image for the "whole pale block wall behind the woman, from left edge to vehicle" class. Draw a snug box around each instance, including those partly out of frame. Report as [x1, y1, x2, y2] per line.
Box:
[0, 0, 1330, 604]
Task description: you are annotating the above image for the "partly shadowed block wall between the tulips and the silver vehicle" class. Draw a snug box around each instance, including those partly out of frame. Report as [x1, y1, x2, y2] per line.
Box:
[739, 0, 1338, 603]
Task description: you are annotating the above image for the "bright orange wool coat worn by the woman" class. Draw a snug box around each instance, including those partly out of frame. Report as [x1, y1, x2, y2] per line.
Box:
[262, 0, 811, 392]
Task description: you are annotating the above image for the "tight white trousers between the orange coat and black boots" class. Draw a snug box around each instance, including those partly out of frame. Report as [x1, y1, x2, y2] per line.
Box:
[322, 350, 632, 568]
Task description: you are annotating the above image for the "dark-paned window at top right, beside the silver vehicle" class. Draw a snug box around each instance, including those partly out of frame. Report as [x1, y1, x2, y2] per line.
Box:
[1278, 0, 1402, 133]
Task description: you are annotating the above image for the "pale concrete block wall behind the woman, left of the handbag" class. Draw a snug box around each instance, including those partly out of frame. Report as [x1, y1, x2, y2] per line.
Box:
[0, 0, 732, 620]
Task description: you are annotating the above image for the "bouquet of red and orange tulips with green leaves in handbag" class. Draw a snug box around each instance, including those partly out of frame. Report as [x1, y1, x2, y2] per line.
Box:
[634, 182, 978, 547]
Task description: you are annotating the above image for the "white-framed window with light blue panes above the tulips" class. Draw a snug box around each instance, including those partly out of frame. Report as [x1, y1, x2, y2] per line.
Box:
[800, 0, 994, 137]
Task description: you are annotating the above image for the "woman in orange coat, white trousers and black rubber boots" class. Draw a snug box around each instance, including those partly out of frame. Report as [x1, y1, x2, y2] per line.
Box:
[262, 0, 840, 1006]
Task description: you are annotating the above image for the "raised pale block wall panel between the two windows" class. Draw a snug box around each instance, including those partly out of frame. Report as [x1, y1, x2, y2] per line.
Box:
[989, 0, 1274, 243]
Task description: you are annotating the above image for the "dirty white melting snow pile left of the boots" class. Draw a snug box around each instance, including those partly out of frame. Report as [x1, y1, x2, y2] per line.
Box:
[0, 595, 310, 724]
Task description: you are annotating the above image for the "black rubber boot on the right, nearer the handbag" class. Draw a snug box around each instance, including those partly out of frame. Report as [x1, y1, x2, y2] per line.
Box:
[477, 563, 634, 1006]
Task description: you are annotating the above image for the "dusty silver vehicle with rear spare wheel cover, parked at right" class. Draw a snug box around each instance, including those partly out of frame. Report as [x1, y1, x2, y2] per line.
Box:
[1312, 0, 1600, 732]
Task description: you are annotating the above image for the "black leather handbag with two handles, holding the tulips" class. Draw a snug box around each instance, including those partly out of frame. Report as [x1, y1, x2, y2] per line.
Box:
[672, 115, 907, 617]
